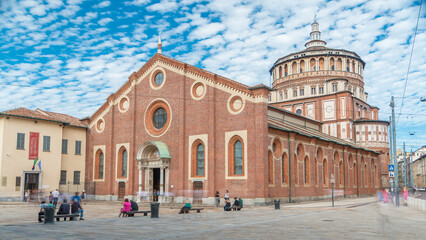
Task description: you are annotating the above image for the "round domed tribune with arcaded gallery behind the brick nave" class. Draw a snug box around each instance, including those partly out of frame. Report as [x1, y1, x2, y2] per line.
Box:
[269, 21, 390, 186]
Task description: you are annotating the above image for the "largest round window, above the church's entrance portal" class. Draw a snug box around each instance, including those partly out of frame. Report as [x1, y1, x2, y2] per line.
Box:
[144, 99, 172, 137]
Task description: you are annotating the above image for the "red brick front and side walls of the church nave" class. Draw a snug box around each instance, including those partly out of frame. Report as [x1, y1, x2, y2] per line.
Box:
[86, 54, 381, 204]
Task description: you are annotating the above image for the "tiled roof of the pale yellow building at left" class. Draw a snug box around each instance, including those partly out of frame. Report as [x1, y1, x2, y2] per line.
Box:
[0, 107, 87, 128]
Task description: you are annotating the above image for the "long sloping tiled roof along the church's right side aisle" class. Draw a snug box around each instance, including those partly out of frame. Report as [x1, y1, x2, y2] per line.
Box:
[268, 117, 377, 153]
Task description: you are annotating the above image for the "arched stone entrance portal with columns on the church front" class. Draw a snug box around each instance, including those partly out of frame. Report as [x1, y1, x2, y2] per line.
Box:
[136, 141, 171, 202]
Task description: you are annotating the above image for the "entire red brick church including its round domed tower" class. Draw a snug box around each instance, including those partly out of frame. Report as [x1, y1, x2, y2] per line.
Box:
[83, 23, 388, 205]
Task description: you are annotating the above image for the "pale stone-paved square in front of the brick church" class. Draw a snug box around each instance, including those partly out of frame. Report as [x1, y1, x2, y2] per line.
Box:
[0, 198, 426, 239]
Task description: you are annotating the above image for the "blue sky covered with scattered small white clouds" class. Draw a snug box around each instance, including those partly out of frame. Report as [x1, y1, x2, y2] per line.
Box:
[0, 0, 426, 150]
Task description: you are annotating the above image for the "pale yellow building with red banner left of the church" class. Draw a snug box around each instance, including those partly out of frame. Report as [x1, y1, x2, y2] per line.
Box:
[0, 108, 87, 200]
